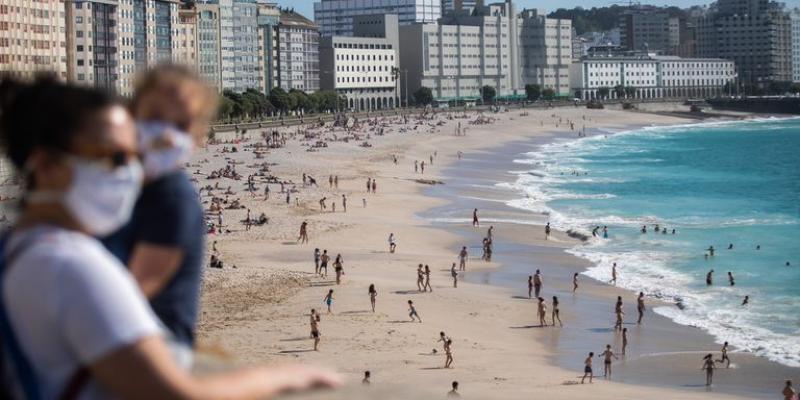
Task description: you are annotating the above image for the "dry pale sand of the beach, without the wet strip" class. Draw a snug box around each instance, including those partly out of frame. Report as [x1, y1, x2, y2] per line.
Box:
[192, 104, 779, 399]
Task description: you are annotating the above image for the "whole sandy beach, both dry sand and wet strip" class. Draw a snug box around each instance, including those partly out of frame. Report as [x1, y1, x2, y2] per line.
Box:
[189, 107, 797, 399]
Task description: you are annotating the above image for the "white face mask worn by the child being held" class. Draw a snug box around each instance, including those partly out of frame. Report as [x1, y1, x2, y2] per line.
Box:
[138, 122, 194, 179]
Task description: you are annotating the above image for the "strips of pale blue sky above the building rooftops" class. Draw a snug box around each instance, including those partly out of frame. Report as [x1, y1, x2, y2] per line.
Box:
[277, 0, 800, 20]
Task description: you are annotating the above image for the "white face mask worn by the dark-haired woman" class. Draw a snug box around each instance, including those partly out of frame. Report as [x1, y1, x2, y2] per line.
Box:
[28, 157, 143, 236]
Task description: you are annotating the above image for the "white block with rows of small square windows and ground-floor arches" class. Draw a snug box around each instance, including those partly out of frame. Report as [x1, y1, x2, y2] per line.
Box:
[319, 14, 399, 111]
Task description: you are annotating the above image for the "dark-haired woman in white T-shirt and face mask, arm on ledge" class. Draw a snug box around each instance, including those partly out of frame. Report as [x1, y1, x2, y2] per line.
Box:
[0, 76, 339, 399]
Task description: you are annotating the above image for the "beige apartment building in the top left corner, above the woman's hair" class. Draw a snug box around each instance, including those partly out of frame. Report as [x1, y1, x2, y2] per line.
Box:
[0, 0, 68, 80]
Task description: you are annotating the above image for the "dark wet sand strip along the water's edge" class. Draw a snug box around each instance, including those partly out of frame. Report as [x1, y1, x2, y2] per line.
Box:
[424, 121, 797, 398]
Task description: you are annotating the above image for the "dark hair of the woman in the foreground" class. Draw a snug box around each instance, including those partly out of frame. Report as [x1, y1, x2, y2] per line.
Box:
[0, 76, 117, 168]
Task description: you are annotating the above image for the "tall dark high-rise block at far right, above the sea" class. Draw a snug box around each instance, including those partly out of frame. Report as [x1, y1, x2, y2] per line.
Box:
[696, 0, 792, 87]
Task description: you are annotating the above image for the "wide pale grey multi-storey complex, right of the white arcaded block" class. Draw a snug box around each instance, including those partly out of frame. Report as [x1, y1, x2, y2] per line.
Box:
[400, 0, 572, 102]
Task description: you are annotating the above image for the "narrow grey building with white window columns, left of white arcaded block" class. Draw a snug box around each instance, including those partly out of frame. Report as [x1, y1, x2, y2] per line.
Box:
[275, 12, 319, 93]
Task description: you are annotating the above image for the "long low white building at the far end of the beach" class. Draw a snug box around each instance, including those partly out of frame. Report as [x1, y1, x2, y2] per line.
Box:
[570, 54, 736, 100]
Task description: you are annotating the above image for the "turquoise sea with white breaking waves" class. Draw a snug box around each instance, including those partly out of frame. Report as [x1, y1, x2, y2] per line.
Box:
[507, 119, 800, 367]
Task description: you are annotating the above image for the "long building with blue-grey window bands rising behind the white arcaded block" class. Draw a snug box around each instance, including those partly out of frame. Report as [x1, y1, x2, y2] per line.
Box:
[314, 0, 442, 36]
